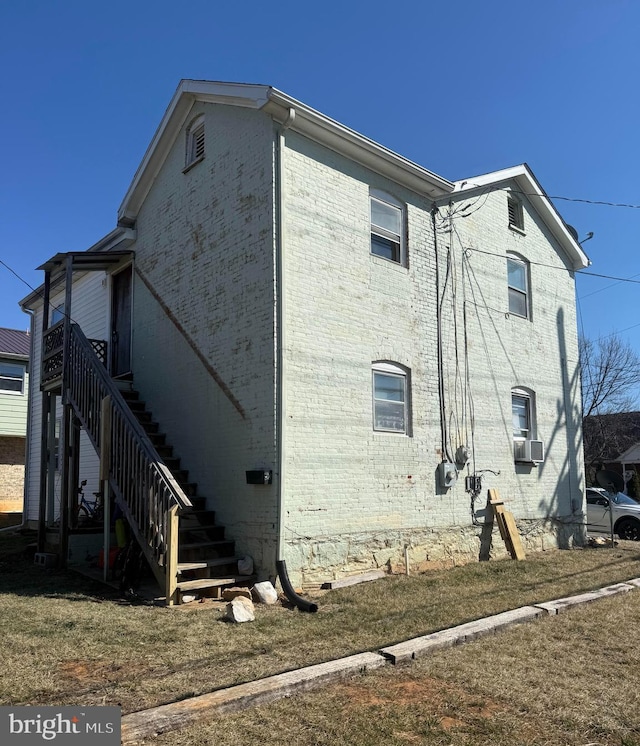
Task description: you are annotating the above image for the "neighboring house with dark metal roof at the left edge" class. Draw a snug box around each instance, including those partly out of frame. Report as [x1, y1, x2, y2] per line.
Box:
[0, 327, 31, 513]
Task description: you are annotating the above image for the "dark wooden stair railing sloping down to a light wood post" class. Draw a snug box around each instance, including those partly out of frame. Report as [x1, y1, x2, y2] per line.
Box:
[64, 324, 191, 588]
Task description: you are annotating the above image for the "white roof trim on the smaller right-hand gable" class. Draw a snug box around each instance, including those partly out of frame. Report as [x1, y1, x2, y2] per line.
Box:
[454, 163, 591, 270]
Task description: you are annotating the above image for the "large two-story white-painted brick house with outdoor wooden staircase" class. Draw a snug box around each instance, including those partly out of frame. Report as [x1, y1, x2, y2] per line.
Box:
[23, 80, 588, 600]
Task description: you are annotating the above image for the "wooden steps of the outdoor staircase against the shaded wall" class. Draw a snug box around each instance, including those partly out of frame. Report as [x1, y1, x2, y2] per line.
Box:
[121, 388, 255, 603]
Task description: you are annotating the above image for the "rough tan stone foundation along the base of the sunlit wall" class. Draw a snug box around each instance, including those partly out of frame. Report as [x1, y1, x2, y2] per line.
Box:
[285, 514, 586, 587]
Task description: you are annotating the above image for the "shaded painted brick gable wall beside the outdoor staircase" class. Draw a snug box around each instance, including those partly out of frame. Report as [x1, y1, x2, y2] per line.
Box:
[132, 104, 277, 570]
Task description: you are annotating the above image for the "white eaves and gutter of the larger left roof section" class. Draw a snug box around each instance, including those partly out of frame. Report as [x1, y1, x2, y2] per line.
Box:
[118, 80, 454, 226]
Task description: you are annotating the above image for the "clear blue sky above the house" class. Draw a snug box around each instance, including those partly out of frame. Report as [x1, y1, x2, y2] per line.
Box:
[0, 0, 640, 372]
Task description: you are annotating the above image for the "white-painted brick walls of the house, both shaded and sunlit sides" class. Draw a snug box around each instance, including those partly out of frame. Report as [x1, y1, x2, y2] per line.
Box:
[23, 104, 583, 582]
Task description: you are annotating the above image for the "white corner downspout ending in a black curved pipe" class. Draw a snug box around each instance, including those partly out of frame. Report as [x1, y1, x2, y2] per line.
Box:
[275, 107, 318, 611]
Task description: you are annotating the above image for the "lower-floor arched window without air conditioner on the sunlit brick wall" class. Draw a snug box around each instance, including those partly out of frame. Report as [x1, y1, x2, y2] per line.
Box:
[372, 361, 409, 435]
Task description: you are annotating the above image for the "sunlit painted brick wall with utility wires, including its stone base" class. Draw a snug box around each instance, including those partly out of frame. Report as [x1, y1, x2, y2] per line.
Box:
[284, 134, 582, 581]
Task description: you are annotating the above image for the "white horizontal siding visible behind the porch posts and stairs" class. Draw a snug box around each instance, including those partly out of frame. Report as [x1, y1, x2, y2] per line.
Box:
[25, 272, 109, 521]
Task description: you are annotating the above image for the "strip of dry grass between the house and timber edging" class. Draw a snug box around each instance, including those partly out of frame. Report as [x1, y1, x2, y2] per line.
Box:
[0, 532, 640, 743]
